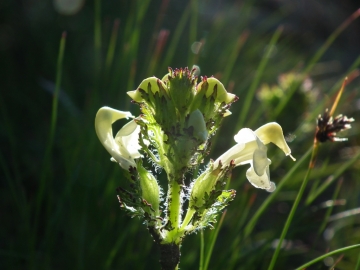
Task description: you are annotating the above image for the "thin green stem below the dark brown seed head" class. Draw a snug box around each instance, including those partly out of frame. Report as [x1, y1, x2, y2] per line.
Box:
[268, 142, 319, 270]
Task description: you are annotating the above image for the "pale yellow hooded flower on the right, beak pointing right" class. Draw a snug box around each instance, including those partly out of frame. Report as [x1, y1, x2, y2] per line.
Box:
[214, 122, 295, 191]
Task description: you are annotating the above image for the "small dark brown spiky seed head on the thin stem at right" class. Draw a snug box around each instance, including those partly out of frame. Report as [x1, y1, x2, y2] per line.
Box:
[315, 110, 354, 142]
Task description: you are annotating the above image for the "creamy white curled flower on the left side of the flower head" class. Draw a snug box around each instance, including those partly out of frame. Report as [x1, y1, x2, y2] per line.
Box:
[95, 107, 141, 170]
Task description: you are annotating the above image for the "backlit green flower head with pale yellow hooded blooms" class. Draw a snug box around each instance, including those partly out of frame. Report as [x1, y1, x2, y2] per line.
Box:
[95, 68, 294, 244]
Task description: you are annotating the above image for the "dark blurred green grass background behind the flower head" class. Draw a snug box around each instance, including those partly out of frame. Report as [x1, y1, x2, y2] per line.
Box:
[0, 0, 360, 269]
